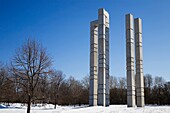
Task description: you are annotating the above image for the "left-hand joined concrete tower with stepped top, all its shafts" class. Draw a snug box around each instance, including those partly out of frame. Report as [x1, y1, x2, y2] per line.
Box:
[89, 8, 110, 106]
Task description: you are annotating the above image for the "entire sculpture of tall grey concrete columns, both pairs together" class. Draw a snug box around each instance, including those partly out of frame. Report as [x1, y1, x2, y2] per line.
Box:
[89, 8, 144, 107]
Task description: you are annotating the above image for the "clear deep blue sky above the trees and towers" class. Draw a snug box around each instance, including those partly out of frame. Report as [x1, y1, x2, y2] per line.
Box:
[0, 0, 170, 81]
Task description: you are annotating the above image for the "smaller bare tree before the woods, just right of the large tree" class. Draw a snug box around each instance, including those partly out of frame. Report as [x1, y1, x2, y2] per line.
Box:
[50, 70, 65, 109]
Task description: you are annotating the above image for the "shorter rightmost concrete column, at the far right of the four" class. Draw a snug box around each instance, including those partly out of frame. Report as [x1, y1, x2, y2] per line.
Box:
[135, 18, 144, 107]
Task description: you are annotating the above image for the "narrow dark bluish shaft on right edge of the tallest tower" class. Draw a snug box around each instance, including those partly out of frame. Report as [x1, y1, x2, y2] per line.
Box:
[105, 12, 110, 106]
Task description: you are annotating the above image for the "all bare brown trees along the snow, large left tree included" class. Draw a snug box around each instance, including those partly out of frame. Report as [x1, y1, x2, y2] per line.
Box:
[0, 39, 170, 113]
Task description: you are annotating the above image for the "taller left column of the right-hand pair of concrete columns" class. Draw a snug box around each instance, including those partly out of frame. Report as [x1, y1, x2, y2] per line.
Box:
[126, 14, 135, 107]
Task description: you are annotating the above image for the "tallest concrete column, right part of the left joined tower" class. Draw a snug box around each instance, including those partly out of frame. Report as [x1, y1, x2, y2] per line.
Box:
[98, 8, 109, 106]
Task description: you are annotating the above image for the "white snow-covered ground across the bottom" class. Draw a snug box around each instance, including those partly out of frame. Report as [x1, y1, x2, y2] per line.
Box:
[0, 104, 170, 113]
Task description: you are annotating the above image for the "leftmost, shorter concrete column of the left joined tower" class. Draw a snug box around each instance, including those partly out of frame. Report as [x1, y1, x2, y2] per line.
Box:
[89, 20, 98, 106]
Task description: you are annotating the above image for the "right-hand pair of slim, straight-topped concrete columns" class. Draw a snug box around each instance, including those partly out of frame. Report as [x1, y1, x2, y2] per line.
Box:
[126, 14, 145, 107]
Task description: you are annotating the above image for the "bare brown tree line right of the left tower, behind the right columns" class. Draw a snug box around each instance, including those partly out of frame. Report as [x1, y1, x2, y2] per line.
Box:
[110, 74, 170, 105]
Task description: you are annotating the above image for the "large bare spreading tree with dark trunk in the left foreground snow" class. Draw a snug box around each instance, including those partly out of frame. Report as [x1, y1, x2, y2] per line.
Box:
[11, 39, 52, 113]
